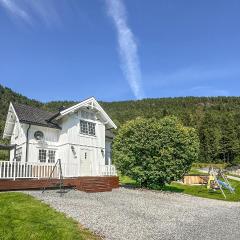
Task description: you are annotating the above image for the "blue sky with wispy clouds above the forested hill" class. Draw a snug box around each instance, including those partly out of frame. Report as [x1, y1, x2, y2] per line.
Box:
[0, 0, 240, 102]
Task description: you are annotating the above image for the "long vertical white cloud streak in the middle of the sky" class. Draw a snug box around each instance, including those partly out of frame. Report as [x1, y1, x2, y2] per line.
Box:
[106, 0, 144, 99]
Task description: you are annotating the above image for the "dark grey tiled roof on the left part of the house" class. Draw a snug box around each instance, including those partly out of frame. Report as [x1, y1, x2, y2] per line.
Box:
[13, 103, 61, 129]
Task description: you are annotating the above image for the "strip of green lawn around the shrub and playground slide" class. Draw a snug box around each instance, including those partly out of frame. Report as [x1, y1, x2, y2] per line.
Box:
[120, 176, 240, 202]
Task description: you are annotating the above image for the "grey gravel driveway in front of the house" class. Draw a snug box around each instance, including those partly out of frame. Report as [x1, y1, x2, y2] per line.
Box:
[25, 188, 240, 240]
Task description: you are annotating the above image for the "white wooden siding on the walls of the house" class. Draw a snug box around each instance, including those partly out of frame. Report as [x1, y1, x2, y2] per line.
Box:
[11, 107, 113, 176]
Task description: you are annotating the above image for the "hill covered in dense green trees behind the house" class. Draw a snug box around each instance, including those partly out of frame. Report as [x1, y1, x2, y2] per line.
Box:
[0, 85, 240, 163]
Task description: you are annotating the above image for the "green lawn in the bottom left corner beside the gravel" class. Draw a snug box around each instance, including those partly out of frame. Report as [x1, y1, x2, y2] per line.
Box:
[0, 193, 100, 240]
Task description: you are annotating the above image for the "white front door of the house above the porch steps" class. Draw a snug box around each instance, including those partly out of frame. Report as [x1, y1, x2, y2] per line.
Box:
[80, 149, 92, 176]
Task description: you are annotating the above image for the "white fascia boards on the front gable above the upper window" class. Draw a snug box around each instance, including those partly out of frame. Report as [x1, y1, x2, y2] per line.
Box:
[56, 97, 117, 129]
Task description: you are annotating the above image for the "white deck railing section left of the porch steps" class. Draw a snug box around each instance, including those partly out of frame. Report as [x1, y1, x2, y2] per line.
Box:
[0, 161, 60, 179]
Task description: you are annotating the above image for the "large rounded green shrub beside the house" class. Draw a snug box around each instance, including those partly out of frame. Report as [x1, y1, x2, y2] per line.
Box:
[113, 117, 199, 187]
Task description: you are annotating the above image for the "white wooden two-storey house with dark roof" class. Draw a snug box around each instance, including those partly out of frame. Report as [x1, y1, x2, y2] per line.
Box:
[0, 97, 116, 178]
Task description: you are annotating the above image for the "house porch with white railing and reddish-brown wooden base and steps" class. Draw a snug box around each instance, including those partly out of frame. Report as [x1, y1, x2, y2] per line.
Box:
[0, 161, 119, 192]
